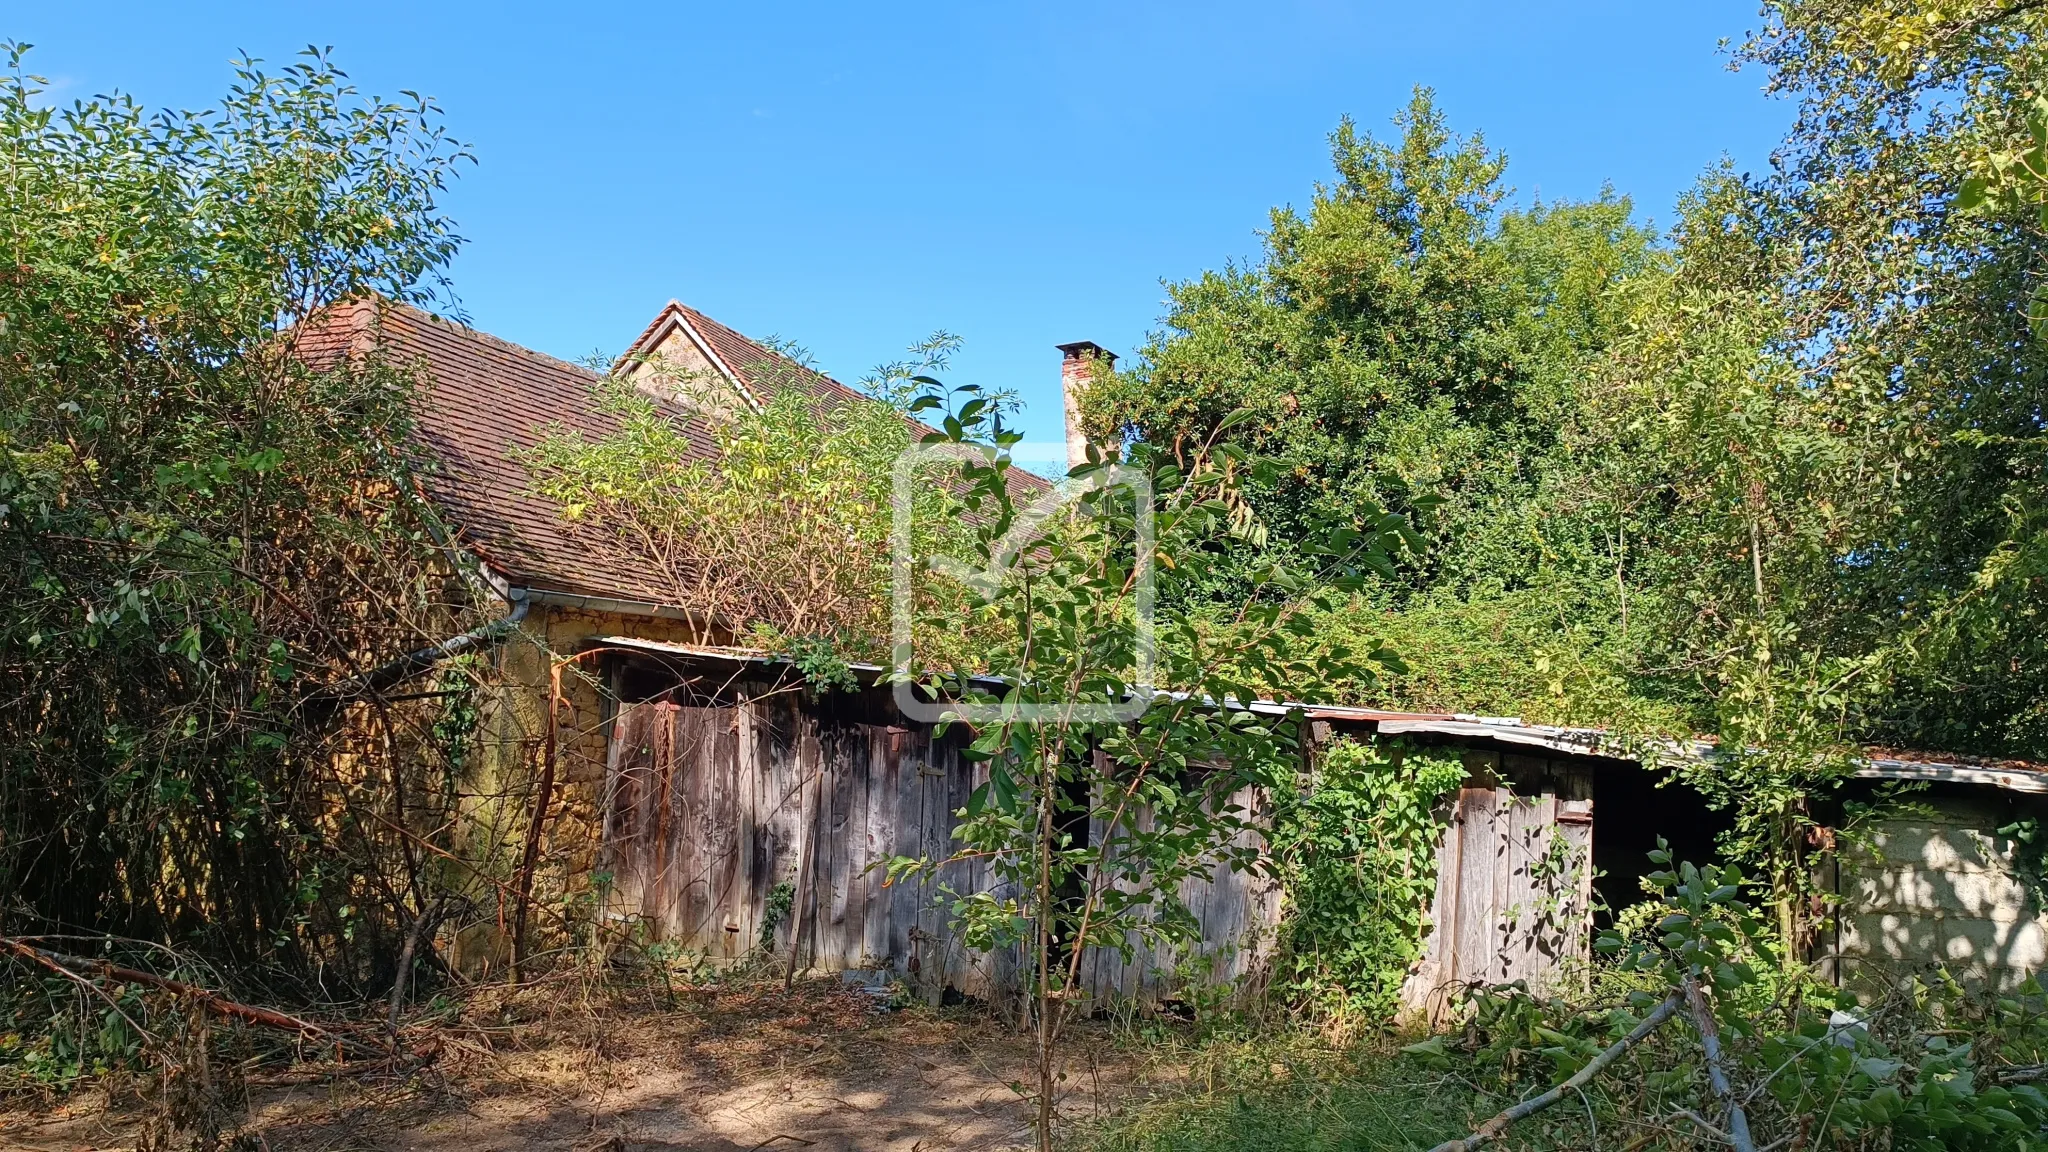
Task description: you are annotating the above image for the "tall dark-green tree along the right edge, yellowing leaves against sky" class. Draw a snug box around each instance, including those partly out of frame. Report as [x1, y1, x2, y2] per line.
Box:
[1720, 0, 2048, 754]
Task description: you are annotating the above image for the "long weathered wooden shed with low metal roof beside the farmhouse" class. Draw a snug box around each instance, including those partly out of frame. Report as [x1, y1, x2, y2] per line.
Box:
[592, 637, 2048, 1019]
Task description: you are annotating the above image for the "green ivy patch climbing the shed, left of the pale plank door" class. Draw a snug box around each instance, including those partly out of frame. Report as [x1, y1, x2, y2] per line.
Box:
[1272, 740, 1464, 1023]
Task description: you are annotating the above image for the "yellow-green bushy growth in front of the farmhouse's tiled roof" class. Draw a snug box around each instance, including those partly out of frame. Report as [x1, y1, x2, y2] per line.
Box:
[520, 336, 1003, 664]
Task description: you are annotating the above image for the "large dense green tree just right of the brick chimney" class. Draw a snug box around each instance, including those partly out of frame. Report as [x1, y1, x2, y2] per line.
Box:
[1083, 90, 1673, 722]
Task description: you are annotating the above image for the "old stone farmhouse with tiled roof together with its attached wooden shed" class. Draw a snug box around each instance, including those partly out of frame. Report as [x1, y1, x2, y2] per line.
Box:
[295, 301, 2048, 1002]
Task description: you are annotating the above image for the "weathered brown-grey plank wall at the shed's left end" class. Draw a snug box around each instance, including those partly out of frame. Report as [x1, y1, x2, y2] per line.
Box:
[604, 691, 989, 998]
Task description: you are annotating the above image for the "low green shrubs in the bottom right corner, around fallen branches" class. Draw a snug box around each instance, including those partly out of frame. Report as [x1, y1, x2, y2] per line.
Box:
[1407, 851, 2048, 1152]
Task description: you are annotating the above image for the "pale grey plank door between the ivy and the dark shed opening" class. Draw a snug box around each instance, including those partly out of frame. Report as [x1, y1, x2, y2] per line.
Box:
[1407, 763, 1593, 1019]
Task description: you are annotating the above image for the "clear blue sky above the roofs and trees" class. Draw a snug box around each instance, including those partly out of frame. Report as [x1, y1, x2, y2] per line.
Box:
[0, 0, 1790, 439]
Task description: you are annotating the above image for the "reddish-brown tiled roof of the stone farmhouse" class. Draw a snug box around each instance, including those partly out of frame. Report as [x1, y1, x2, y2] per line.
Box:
[291, 301, 1047, 605]
